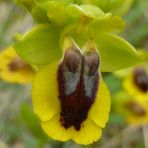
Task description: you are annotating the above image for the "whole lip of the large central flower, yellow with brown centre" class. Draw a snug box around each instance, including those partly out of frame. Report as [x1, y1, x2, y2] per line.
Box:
[33, 38, 110, 145]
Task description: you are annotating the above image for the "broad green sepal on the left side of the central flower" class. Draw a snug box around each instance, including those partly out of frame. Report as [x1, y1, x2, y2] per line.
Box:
[14, 24, 62, 66]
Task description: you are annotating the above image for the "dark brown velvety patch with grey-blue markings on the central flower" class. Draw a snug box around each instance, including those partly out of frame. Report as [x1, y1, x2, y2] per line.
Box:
[58, 44, 100, 130]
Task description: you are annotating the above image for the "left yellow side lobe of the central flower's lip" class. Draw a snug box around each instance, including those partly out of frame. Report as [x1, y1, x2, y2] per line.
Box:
[32, 62, 60, 121]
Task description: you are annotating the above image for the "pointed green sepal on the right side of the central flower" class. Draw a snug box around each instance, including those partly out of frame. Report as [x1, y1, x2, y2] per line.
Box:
[96, 34, 142, 72]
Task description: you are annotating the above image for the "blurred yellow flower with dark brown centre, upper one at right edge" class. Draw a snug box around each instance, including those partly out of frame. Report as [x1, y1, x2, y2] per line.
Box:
[123, 67, 148, 98]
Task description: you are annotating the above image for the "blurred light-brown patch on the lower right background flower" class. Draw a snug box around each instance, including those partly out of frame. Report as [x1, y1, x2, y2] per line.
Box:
[125, 102, 146, 117]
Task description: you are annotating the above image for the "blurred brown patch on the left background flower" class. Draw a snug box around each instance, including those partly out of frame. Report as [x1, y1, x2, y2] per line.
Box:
[8, 57, 32, 71]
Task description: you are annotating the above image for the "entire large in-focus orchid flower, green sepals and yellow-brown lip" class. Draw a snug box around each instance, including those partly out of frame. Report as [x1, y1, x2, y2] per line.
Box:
[14, 0, 140, 144]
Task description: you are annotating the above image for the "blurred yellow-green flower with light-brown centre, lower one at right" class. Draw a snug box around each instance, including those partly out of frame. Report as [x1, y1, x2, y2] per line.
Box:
[113, 92, 148, 125]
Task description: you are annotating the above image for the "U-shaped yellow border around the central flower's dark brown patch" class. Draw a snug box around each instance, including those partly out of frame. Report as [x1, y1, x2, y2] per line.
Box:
[32, 37, 110, 144]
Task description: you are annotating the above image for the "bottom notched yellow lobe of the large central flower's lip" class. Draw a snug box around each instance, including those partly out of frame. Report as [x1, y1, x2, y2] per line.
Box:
[42, 114, 102, 145]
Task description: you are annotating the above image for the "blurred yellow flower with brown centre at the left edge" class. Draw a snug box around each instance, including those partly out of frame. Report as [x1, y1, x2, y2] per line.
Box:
[0, 47, 35, 84]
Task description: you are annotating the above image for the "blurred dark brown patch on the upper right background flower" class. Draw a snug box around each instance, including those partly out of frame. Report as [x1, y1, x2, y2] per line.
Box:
[134, 68, 148, 93]
